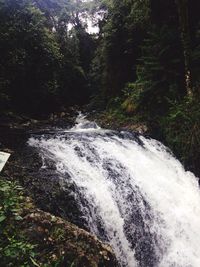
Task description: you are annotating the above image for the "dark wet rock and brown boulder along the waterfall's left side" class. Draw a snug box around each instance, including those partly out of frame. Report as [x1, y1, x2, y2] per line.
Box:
[0, 113, 117, 267]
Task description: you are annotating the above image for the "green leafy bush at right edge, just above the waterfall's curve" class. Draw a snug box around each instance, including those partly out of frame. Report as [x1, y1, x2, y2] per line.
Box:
[161, 98, 200, 171]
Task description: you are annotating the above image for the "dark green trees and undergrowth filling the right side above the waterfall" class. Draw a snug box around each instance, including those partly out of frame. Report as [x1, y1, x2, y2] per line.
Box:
[88, 0, 200, 175]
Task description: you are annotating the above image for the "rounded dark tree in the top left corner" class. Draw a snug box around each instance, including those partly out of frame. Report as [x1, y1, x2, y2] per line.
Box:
[0, 0, 62, 114]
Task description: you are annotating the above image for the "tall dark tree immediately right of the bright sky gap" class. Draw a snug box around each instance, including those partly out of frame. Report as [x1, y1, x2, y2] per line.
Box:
[91, 0, 150, 99]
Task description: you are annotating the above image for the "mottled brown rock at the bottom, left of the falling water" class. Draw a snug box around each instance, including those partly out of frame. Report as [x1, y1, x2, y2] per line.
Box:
[22, 209, 117, 267]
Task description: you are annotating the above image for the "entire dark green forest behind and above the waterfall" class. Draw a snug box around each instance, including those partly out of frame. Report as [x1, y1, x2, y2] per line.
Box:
[0, 0, 200, 174]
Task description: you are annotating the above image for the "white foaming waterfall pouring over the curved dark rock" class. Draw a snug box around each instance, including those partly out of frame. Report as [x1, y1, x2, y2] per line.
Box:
[28, 115, 200, 267]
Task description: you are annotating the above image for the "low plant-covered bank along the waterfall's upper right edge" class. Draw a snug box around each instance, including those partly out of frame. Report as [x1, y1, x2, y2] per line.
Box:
[88, 105, 200, 177]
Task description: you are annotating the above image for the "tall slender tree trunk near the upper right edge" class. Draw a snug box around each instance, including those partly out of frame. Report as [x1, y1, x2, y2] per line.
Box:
[175, 0, 193, 96]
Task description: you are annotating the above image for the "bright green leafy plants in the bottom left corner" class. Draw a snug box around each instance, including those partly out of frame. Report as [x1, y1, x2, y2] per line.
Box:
[0, 179, 36, 267]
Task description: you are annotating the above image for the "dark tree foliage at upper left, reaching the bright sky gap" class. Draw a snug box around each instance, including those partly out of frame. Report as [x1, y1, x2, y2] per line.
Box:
[0, 0, 94, 116]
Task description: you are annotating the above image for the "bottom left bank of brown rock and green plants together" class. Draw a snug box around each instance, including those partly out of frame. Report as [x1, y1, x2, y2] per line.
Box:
[0, 175, 116, 267]
